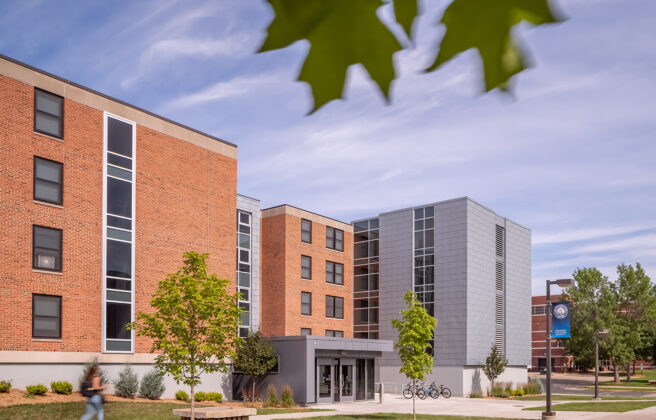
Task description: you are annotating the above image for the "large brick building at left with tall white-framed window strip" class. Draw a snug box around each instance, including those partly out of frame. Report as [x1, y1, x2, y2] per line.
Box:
[0, 56, 241, 393]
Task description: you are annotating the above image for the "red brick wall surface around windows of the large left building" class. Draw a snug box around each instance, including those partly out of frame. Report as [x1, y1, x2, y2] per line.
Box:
[0, 76, 236, 352]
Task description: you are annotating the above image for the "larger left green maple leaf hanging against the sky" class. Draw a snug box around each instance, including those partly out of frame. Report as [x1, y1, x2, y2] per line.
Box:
[259, 0, 401, 113]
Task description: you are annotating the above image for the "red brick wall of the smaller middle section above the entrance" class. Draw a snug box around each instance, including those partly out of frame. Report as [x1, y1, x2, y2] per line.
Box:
[262, 210, 353, 337]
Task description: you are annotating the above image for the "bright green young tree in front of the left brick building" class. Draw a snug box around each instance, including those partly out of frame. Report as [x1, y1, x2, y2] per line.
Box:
[129, 251, 241, 420]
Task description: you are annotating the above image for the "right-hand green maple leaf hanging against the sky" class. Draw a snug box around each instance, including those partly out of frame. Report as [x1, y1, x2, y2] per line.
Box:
[426, 0, 562, 91]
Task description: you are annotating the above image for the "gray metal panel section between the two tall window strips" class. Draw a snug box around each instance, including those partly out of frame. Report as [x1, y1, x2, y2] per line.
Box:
[378, 209, 413, 366]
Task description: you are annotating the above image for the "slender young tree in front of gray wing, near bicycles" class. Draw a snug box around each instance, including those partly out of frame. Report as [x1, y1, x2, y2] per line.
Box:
[392, 290, 437, 420]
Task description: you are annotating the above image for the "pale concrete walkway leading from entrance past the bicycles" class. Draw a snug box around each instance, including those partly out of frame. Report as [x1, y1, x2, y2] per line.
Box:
[251, 394, 656, 420]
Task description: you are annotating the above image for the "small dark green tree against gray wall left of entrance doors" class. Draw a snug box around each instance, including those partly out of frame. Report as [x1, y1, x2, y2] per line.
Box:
[234, 330, 278, 401]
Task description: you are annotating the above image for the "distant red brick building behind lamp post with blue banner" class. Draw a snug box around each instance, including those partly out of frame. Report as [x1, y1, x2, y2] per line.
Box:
[531, 295, 574, 372]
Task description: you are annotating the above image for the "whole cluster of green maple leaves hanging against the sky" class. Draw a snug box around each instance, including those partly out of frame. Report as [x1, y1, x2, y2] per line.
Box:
[259, 0, 563, 112]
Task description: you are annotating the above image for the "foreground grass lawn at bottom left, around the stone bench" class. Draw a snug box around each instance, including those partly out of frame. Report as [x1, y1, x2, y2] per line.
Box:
[0, 402, 332, 420]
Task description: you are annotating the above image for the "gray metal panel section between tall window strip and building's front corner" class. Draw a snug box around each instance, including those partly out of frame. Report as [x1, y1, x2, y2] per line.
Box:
[435, 199, 468, 366]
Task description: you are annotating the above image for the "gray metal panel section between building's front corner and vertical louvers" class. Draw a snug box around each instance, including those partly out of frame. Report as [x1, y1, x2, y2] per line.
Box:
[466, 200, 502, 365]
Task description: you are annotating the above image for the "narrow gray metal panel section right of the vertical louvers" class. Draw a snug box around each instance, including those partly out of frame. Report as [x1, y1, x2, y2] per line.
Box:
[506, 220, 531, 366]
